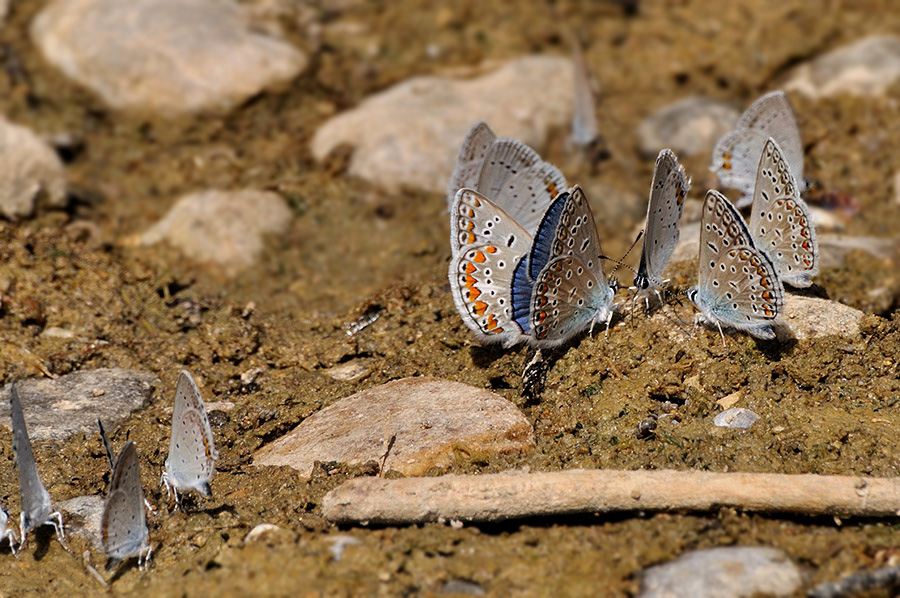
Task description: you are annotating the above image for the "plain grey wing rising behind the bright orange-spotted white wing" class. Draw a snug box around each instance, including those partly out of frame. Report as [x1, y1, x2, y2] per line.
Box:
[475, 139, 566, 233]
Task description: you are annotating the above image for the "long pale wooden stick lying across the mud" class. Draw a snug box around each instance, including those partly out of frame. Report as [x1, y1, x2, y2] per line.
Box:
[322, 470, 900, 525]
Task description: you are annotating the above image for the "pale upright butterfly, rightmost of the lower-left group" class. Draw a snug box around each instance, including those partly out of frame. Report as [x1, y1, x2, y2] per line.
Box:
[160, 370, 219, 505]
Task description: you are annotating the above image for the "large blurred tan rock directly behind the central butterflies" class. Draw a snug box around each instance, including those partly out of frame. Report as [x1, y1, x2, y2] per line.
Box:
[312, 56, 574, 193]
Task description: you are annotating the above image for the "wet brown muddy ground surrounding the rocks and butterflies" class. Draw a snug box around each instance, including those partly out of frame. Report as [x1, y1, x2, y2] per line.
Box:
[0, 0, 900, 597]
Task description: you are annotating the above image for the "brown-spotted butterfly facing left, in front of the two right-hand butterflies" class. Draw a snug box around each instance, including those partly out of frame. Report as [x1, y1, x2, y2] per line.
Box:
[688, 190, 784, 342]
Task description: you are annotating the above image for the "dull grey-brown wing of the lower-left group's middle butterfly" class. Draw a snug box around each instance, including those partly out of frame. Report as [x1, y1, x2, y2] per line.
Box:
[100, 441, 149, 561]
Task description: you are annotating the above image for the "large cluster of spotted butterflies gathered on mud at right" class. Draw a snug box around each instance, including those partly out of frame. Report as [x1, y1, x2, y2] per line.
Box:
[448, 92, 819, 348]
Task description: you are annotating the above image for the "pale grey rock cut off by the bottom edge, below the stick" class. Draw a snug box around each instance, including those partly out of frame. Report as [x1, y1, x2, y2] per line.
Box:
[639, 546, 803, 598]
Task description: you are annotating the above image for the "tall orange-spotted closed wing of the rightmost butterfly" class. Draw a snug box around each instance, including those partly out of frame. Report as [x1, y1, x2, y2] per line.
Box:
[750, 138, 819, 287]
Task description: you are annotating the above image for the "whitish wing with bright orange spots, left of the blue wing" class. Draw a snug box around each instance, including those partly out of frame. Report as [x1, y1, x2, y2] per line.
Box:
[449, 189, 531, 346]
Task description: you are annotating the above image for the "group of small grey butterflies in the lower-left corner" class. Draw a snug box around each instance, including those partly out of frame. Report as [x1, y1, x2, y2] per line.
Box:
[0, 371, 218, 568]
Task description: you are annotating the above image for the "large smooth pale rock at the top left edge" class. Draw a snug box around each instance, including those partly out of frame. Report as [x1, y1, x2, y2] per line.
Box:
[31, 0, 307, 114]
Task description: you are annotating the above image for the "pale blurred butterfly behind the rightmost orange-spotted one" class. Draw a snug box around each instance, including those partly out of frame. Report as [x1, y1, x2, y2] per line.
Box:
[711, 91, 806, 207]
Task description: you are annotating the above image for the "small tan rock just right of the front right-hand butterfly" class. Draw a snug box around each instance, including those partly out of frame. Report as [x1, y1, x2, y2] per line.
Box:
[784, 293, 863, 340]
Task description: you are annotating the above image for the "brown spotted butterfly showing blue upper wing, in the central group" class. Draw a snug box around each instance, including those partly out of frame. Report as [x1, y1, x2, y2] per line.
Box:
[512, 186, 615, 348]
